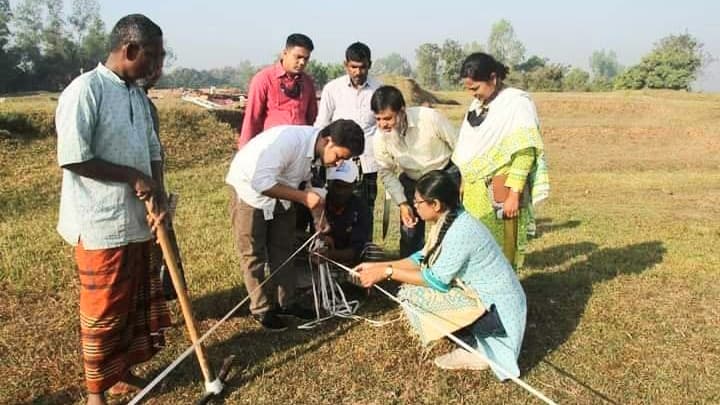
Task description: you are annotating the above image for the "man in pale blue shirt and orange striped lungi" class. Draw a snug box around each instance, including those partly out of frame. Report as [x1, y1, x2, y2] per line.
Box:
[55, 14, 170, 404]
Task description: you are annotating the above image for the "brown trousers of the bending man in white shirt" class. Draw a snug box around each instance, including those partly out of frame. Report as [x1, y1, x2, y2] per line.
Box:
[230, 187, 297, 314]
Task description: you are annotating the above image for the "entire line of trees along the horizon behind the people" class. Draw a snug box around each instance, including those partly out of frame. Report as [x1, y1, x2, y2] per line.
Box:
[0, 0, 712, 93]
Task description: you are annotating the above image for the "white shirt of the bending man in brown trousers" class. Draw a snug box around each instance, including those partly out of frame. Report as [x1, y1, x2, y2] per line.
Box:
[225, 125, 320, 220]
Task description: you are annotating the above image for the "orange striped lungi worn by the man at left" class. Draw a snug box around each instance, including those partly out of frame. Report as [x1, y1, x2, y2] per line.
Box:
[75, 241, 170, 394]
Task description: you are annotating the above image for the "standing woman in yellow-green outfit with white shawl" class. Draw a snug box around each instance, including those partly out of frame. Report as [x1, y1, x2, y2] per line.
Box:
[452, 53, 549, 269]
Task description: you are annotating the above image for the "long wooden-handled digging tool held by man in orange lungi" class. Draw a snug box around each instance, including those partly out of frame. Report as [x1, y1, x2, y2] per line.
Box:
[145, 199, 229, 403]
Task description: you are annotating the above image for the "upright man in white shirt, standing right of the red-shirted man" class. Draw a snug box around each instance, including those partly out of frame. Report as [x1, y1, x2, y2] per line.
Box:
[315, 42, 381, 240]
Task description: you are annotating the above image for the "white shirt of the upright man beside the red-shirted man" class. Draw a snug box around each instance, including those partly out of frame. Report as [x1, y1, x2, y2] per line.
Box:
[315, 75, 382, 173]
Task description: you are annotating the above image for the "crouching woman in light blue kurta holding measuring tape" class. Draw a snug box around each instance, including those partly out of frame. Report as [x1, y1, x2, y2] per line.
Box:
[355, 171, 527, 380]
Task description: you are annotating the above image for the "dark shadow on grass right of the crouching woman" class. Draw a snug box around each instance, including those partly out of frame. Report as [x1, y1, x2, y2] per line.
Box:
[520, 241, 666, 402]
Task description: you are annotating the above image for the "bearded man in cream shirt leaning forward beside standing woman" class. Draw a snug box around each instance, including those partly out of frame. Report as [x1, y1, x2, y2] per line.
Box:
[371, 86, 460, 257]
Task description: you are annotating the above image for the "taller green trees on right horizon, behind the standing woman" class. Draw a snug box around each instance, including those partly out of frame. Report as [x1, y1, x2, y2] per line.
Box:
[415, 20, 713, 91]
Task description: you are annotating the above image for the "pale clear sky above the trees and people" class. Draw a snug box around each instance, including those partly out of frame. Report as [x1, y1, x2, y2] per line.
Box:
[11, 0, 720, 92]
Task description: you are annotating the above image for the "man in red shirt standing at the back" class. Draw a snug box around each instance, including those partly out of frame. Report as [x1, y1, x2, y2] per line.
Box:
[238, 34, 318, 149]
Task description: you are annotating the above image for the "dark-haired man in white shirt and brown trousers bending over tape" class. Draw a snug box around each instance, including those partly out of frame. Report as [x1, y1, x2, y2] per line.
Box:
[225, 120, 365, 331]
